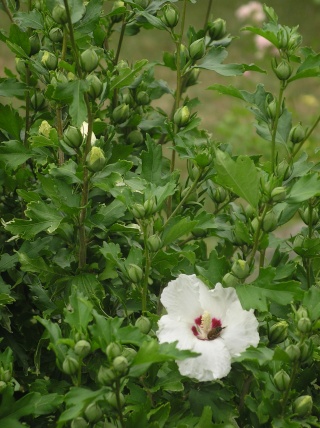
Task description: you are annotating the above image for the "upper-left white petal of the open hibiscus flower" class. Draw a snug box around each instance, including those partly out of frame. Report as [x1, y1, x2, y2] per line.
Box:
[161, 274, 208, 323]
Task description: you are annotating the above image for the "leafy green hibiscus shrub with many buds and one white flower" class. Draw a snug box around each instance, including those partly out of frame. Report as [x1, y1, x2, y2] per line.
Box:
[0, 0, 320, 428]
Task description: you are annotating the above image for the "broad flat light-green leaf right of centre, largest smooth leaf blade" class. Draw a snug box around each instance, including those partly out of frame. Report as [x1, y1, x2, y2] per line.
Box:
[214, 150, 259, 208]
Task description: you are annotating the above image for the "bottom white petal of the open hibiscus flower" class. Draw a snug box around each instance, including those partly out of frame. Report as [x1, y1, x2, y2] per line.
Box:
[177, 339, 231, 382]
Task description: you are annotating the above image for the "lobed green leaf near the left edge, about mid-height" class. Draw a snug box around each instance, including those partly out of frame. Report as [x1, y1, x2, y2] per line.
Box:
[5, 201, 63, 239]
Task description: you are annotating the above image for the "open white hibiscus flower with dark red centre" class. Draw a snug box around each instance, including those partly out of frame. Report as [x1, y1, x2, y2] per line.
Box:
[157, 275, 259, 381]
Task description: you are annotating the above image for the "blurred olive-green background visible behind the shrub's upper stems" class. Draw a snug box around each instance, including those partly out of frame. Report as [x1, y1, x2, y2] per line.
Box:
[0, 0, 320, 156]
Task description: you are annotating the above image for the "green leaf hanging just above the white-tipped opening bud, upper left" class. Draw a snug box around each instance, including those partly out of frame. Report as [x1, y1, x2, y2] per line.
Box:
[53, 80, 89, 127]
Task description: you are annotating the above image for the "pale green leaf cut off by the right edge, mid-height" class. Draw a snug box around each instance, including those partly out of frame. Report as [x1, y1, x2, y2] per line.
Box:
[286, 174, 320, 204]
